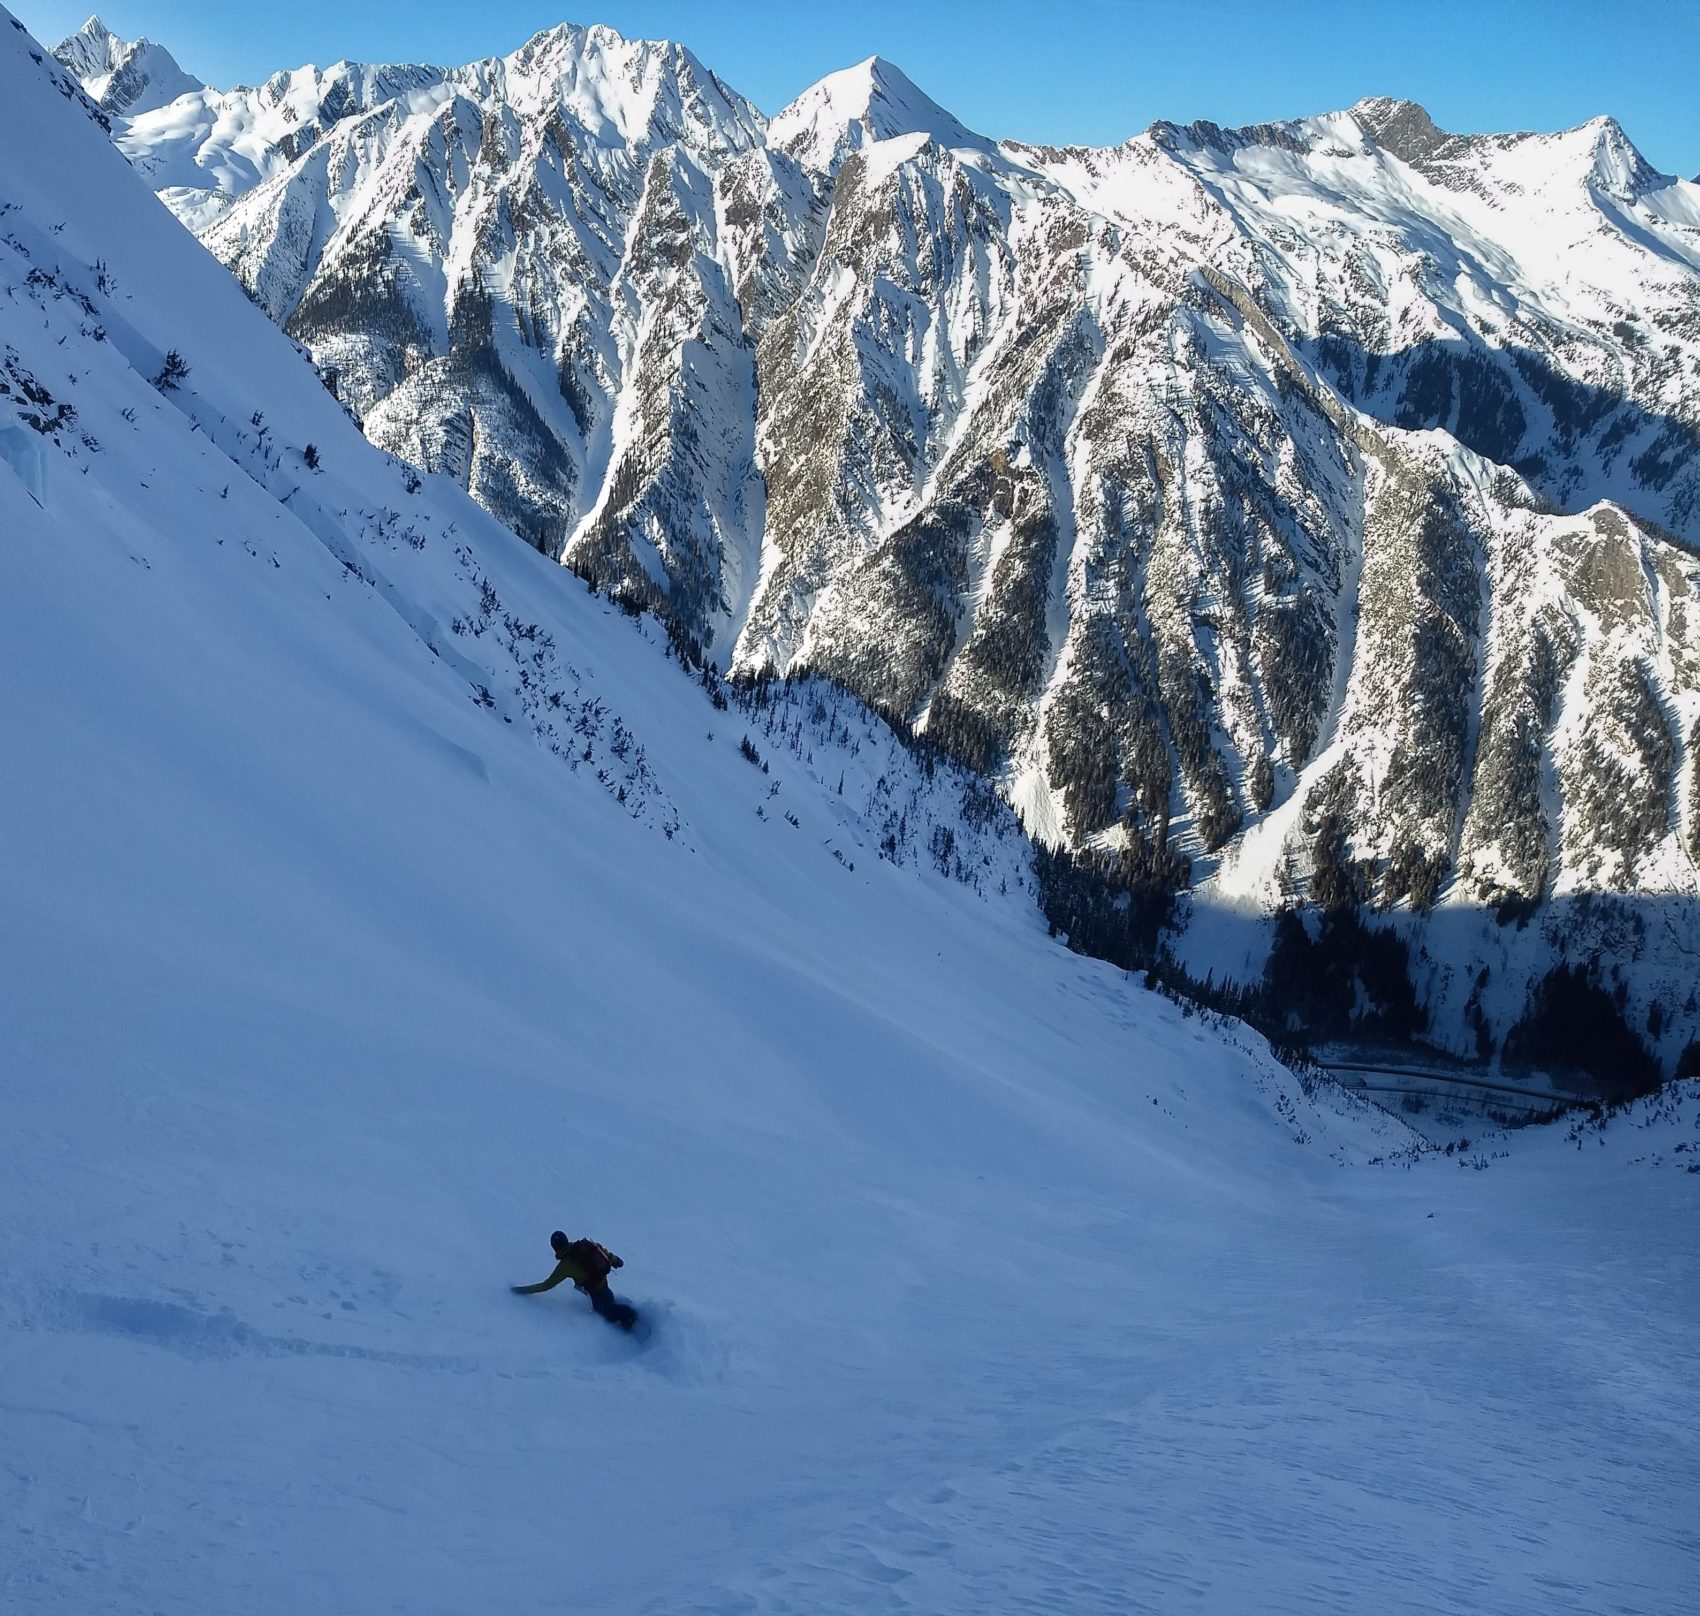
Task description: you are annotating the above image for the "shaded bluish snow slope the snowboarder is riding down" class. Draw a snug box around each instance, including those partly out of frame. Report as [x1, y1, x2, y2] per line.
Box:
[0, 12, 1700, 1616]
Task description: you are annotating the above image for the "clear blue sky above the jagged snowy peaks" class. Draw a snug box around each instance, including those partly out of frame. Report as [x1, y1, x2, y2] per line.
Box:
[7, 0, 1700, 178]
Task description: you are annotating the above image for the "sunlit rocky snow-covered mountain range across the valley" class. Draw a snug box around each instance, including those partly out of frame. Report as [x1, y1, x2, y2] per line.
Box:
[46, 20, 1700, 1057]
